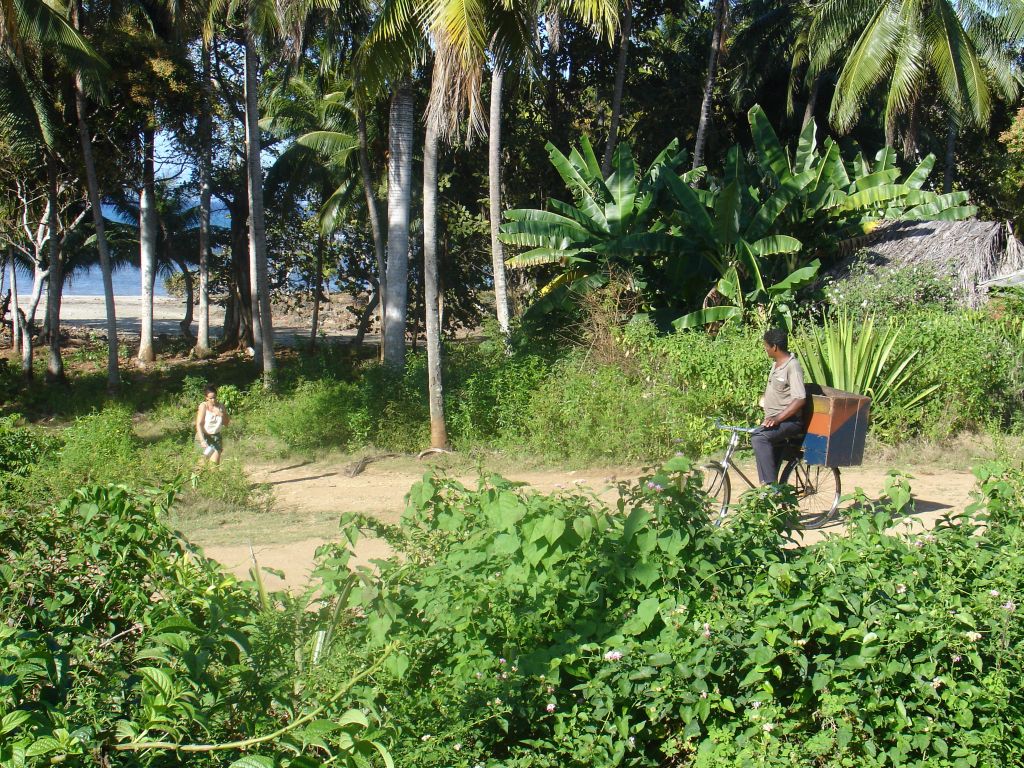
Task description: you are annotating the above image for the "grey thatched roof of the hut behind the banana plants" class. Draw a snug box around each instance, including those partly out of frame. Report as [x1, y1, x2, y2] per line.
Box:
[829, 221, 1024, 306]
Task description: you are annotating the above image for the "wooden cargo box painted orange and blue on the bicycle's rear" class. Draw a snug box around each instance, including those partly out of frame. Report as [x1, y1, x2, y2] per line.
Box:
[804, 384, 871, 467]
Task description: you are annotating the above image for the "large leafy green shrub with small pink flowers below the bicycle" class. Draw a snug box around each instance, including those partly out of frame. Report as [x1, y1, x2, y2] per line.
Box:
[309, 460, 1024, 768]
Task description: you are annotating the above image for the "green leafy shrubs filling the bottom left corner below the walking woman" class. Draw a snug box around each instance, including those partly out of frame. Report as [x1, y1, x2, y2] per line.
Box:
[0, 486, 383, 768]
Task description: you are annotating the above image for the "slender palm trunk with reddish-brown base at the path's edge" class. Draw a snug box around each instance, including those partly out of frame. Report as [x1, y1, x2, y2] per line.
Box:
[423, 118, 447, 450]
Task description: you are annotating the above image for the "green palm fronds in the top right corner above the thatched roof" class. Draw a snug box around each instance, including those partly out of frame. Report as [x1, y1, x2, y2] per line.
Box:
[810, 0, 1024, 160]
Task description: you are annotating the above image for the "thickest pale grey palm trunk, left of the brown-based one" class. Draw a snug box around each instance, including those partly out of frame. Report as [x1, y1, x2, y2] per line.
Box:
[384, 80, 414, 368]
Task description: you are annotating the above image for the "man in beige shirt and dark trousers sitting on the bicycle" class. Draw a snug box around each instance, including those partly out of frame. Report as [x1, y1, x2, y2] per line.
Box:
[751, 328, 807, 485]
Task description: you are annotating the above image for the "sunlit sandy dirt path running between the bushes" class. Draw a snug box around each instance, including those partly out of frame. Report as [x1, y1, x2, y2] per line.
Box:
[189, 459, 975, 589]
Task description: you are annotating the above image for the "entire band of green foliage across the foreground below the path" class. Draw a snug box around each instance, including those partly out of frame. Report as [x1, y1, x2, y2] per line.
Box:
[6, 458, 1024, 768]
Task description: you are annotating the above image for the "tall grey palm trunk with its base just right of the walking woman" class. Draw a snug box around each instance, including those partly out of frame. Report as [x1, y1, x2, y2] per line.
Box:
[239, 27, 274, 388]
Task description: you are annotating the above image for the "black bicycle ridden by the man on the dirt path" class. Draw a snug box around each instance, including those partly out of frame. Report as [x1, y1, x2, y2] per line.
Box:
[696, 421, 843, 528]
